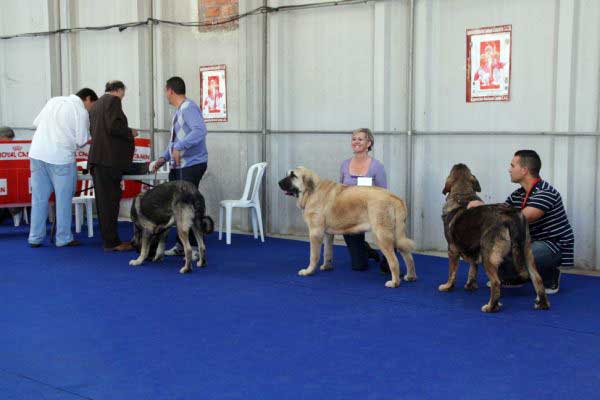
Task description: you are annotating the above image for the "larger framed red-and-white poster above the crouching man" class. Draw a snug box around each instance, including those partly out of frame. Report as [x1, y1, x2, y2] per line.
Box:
[467, 25, 512, 103]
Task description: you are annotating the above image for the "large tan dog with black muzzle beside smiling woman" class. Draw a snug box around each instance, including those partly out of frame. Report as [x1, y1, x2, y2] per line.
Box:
[279, 167, 417, 288]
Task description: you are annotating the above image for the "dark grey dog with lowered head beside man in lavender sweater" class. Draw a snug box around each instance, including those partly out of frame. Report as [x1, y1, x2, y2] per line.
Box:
[129, 181, 214, 274]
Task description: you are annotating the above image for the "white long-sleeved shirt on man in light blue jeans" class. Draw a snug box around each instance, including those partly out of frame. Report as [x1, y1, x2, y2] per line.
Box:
[29, 94, 90, 164]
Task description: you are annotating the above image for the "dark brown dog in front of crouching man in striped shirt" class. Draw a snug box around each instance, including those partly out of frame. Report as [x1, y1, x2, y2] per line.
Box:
[438, 164, 550, 312]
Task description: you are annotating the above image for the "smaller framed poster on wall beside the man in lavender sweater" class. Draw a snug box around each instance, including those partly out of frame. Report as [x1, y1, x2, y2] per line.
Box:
[200, 65, 227, 122]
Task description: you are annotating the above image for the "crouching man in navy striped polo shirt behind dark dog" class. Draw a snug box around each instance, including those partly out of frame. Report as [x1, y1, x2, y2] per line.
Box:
[469, 150, 575, 294]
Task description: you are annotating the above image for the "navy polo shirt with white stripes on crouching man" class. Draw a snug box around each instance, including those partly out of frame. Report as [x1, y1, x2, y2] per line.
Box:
[506, 180, 575, 267]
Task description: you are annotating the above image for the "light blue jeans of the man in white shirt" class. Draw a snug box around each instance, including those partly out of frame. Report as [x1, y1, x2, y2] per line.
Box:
[29, 158, 77, 247]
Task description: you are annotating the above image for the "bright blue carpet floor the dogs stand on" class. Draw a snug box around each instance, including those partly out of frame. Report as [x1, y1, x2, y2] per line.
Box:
[0, 223, 600, 400]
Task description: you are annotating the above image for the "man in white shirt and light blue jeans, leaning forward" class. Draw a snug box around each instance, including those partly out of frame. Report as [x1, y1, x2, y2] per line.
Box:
[29, 88, 98, 247]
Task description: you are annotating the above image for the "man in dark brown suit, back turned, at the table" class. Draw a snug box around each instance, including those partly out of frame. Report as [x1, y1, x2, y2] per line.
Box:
[88, 81, 137, 251]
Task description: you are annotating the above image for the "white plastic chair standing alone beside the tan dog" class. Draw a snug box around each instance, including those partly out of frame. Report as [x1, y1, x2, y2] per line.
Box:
[219, 162, 267, 244]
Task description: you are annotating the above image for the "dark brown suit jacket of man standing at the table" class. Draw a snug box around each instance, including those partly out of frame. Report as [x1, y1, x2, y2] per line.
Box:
[88, 94, 135, 170]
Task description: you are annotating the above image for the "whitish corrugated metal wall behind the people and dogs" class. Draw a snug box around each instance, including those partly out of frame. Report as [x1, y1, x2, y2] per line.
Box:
[0, 0, 600, 268]
